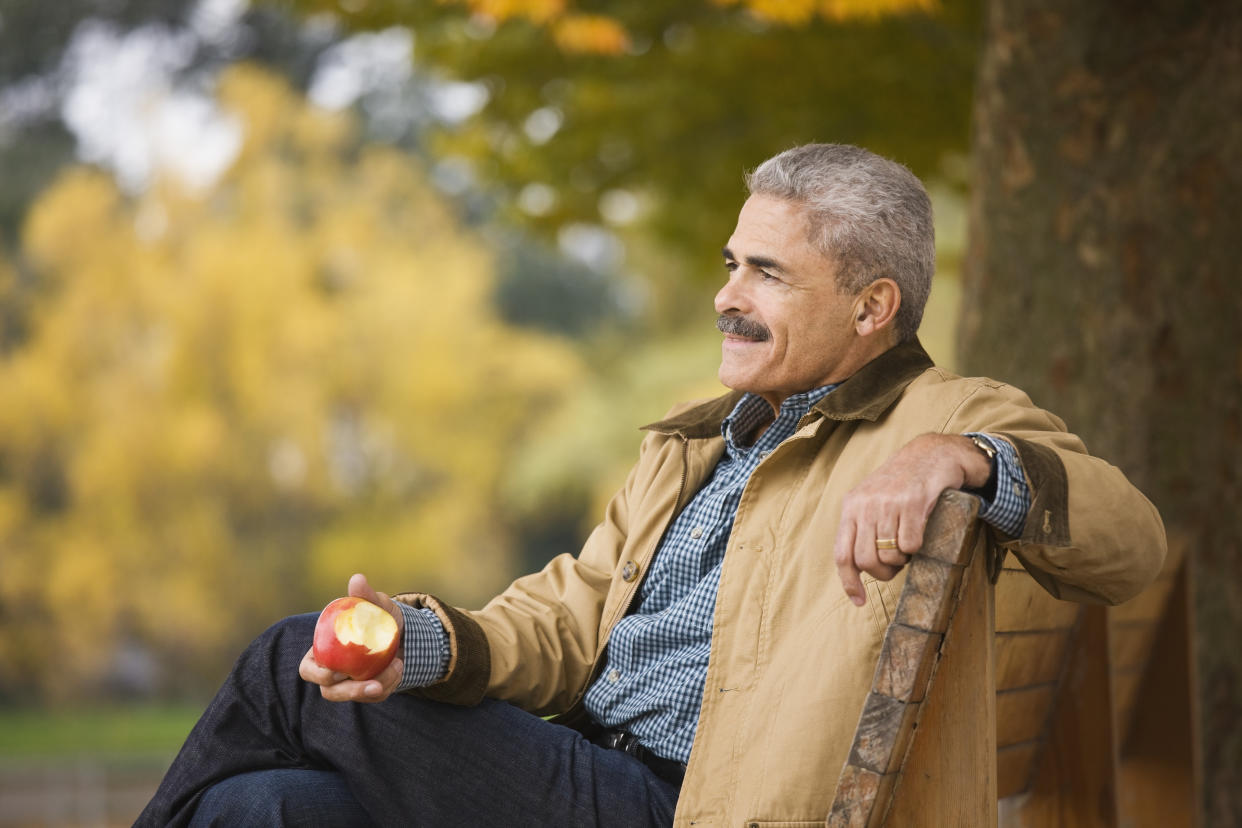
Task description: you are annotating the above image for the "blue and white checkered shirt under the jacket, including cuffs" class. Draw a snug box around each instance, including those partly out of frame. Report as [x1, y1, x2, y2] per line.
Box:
[401, 386, 1030, 762]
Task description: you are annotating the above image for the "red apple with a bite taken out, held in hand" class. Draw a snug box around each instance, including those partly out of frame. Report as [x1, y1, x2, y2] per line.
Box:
[314, 596, 399, 682]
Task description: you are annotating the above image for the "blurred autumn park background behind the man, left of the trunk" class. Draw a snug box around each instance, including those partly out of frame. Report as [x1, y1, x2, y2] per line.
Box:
[0, 0, 1236, 824]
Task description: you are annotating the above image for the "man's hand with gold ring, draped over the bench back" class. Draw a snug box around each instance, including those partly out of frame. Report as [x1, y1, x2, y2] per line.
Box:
[833, 434, 991, 607]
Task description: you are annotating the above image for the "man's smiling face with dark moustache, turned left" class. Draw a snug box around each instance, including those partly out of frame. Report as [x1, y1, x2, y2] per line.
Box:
[715, 195, 858, 408]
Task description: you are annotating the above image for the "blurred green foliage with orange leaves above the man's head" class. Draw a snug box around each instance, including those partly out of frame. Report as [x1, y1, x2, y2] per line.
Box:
[276, 0, 981, 310]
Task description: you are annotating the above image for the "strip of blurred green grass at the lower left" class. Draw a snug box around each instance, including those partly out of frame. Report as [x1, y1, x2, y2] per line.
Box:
[0, 705, 202, 761]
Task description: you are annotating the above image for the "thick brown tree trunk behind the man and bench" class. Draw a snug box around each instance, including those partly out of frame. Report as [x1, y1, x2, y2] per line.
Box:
[959, 0, 1242, 826]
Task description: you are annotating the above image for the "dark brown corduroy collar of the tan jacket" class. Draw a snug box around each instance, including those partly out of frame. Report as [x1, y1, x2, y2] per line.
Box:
[642, 338, 933, 439]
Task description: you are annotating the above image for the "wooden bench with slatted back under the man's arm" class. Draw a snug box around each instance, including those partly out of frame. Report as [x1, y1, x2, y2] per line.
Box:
[827, 492, 1195, 828]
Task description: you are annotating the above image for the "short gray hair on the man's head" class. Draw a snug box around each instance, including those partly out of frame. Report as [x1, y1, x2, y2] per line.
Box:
[746, 144, 935, 341]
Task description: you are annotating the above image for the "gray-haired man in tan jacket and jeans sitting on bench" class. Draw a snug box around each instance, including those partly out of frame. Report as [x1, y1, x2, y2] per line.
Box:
[139, 144, 1165, 826]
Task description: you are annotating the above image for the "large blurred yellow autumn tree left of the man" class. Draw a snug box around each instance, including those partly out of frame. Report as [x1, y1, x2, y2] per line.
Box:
[0, 67, 578, 699]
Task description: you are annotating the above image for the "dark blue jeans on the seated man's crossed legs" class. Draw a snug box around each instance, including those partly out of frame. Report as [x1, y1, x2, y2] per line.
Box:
[135, 614, 678, 828]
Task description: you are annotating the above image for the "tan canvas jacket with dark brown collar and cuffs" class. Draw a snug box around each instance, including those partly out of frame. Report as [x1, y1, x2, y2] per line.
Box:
[399, 343, 1165, 827]
